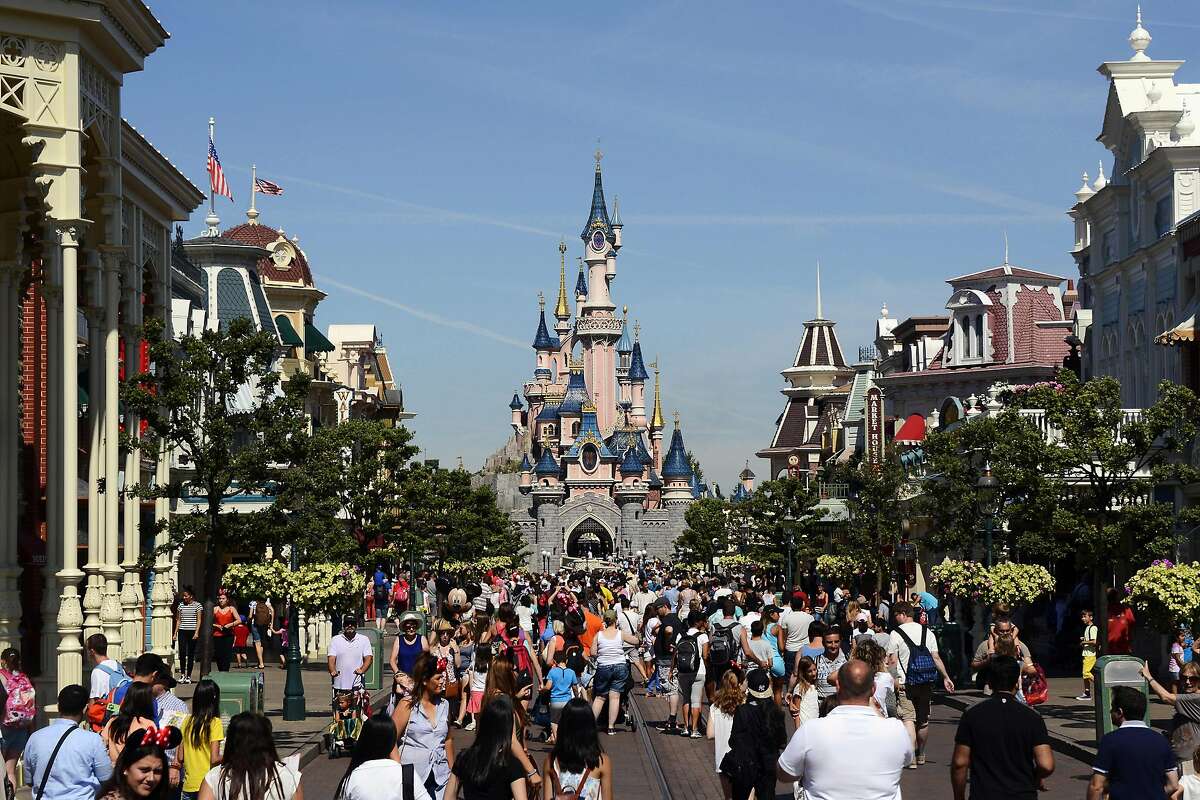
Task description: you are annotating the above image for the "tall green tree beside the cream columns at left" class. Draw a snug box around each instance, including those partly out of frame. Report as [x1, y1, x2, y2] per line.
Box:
[121, 318, 308, 672]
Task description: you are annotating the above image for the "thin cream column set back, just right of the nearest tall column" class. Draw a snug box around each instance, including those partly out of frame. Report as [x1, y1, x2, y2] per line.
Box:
[83, 292, 104, 639]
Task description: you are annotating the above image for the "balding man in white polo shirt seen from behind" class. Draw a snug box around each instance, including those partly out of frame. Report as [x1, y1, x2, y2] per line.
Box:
[778, 660, 912, 800]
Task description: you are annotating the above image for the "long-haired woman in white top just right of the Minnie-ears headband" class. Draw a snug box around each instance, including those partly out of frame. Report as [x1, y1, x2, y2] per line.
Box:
[199, 711, 304, 800]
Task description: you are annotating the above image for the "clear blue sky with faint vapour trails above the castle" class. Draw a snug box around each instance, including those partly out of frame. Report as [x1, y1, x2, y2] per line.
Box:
[124, 0, 1200, 491]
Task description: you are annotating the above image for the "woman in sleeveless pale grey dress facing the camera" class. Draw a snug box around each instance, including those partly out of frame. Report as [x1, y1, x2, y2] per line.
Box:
[391, 652, 454, 800]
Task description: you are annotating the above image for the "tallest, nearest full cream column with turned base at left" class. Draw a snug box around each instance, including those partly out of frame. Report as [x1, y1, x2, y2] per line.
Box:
[50, 225, 85, 688]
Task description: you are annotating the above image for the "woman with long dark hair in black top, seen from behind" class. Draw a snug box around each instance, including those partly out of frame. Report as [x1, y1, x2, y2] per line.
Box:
[446, 694, 527, 800]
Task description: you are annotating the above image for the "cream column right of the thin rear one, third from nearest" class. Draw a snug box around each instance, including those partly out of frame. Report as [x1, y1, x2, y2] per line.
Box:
[100, 253, 123, 661]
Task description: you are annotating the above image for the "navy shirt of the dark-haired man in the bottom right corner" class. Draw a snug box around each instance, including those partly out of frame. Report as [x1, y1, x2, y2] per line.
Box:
[1092, 721, 1178, 800]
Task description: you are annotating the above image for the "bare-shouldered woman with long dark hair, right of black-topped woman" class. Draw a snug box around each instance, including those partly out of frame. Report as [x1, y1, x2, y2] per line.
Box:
[541, 698, 612, 800]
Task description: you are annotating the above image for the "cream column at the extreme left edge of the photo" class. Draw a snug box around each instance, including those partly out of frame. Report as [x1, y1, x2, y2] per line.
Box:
[0, 263, 20, 648]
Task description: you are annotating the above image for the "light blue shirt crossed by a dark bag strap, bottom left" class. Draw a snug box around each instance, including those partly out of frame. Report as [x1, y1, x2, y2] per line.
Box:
[25, 720, 113, 800]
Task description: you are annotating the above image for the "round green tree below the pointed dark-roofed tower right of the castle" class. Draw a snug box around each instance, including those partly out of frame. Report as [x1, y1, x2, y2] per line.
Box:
[739, 477, 826, 567]
